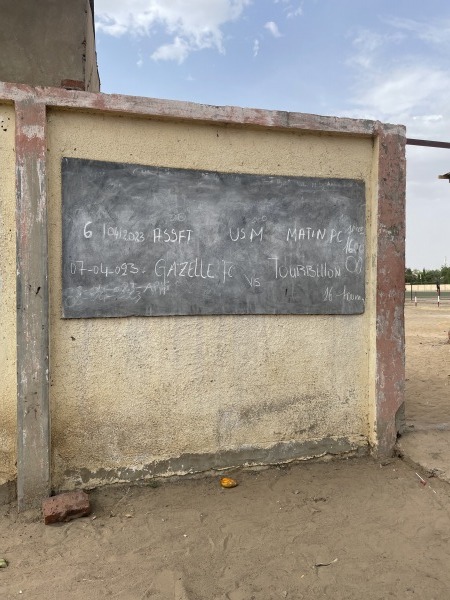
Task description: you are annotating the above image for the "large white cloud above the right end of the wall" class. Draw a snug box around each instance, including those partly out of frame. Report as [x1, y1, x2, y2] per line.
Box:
[347, 21, 450, 137]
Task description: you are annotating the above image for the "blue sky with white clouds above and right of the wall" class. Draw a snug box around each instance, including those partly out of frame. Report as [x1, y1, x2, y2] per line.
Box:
[95, 0, 450, 269]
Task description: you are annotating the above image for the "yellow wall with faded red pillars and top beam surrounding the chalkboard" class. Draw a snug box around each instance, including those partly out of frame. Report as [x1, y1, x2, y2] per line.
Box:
[0, 84, 405, 508]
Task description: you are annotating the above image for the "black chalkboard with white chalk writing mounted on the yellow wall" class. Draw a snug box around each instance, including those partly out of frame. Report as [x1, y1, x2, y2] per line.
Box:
[62, 158, 365, 318]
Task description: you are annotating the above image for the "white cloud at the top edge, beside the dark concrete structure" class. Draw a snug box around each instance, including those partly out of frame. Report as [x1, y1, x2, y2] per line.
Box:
[95, 0, 251, 63]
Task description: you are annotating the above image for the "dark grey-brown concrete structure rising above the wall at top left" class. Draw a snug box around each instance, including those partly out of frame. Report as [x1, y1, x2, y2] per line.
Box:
[0, 0, 100, 92]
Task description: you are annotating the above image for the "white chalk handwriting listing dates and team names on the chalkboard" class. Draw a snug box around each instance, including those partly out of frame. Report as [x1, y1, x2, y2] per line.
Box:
[63, 191, 365, 314]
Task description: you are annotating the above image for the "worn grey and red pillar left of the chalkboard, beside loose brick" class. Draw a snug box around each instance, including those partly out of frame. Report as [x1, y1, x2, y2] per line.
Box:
[16, 99, 50, 510]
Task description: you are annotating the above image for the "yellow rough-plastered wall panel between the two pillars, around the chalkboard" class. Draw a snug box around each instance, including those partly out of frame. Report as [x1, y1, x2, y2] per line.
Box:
[48, 111, 376, 488]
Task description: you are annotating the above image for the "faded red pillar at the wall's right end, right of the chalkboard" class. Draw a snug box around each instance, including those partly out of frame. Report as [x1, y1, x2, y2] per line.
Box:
[374, 123, 406, 456]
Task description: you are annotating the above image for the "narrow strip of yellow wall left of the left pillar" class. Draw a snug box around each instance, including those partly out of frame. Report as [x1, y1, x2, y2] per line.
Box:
[0, 104, 17, 486]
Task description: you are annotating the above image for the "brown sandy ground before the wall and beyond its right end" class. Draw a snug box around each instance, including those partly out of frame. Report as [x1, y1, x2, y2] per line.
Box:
[0, 306, 450, 600]
